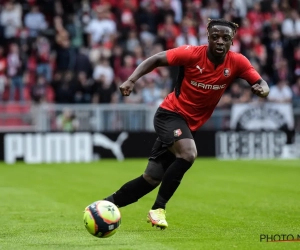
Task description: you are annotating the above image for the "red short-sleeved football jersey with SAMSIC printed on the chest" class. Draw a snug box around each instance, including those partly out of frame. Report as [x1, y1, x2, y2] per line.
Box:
[160, 45, 261, 131]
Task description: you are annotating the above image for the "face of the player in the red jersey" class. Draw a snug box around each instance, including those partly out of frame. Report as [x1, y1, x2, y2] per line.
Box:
[208, 25, 233, 57]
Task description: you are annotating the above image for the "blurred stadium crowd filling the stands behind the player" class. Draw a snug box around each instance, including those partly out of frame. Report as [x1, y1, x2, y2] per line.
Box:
[0, 0, 300, 108]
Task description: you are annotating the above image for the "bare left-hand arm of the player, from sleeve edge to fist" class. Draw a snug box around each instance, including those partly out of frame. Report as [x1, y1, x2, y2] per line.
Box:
[120, 51, 169, 96]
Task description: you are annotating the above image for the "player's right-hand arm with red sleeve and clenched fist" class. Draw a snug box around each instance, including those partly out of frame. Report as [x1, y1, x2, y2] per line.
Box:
[236, 54, 270, 98]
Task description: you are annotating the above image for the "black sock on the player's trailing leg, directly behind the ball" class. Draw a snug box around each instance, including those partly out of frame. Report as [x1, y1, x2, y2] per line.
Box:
[104, 175, 156, 207]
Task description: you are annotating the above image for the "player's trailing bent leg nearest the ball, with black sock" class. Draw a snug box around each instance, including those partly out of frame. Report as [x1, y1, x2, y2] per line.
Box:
[105, 141, 175, 207]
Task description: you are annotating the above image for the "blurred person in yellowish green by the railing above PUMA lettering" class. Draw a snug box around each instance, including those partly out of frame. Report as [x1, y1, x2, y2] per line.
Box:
[56, 109, 79, 132]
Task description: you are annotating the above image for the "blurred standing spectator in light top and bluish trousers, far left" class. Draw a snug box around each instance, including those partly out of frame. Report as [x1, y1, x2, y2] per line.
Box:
[7, 43, 24, 101]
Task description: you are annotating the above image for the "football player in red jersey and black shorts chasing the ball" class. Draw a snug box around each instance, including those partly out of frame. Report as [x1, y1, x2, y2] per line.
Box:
[105, 19, 269, 229]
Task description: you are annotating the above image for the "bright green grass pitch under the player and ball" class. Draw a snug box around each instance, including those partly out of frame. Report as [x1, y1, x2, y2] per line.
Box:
[0, 159, 300, 250]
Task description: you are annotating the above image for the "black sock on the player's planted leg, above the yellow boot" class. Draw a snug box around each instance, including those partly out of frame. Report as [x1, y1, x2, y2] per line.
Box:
[152, 158, 192, 209]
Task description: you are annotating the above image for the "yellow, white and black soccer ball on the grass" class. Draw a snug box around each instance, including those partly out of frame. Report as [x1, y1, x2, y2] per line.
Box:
[83, 200, 121, 238]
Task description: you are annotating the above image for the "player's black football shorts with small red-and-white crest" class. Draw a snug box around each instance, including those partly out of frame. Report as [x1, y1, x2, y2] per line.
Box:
[149, 107, 196, 159]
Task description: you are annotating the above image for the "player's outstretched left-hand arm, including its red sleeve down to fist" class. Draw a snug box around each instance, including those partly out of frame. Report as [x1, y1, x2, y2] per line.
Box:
[120, 45, 193, 96]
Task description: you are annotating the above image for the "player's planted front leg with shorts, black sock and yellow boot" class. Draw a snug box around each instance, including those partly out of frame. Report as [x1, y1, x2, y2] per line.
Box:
[148, 107, 197, 229]
